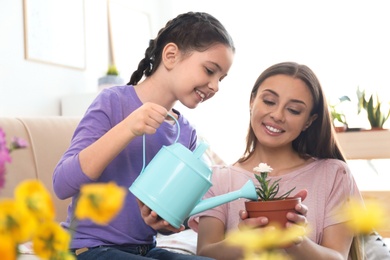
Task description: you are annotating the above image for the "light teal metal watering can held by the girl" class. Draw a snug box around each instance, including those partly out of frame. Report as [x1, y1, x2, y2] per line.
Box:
[129, 114, 257, 228]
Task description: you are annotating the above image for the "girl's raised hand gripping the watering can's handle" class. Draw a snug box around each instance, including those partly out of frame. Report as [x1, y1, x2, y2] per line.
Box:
[125, 103, 168, 136]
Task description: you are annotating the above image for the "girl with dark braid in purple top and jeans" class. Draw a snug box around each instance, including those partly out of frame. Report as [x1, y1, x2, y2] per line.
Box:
[53, 12, 235, 260]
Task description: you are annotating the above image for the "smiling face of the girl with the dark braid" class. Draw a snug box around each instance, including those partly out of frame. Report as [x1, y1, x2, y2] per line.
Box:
[171, 44, 234, 108]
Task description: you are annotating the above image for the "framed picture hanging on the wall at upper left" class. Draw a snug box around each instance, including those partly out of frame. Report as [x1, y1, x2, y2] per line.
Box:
[23, 0, 85, 70]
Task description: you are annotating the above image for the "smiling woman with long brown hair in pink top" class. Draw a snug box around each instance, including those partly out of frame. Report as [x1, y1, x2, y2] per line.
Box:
[189, 62, 361, 259]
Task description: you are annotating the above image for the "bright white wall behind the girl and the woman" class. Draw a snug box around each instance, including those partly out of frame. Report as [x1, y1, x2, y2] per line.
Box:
[0, 0, 390, 162]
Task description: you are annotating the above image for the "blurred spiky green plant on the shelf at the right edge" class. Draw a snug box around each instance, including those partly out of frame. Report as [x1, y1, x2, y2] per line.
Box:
[356, 87, 390, 129]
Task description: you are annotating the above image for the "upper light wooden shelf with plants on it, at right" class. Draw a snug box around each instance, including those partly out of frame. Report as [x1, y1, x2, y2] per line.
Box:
[337, 130, 390, 160]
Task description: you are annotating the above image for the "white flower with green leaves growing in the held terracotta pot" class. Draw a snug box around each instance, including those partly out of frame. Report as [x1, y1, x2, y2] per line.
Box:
[253, 163, 295, 201]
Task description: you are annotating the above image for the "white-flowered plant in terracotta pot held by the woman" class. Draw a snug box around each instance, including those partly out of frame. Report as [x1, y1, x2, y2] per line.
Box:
[245, 163, 301, 227]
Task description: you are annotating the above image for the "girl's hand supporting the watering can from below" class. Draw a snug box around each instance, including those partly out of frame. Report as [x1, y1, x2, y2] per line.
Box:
[137, 199, 184, 234]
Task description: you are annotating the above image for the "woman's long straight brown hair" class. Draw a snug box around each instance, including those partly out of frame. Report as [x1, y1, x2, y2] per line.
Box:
[238, 62, 345, 162]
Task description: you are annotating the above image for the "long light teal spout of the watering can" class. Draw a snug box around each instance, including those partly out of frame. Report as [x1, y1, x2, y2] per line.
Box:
[189, 180, 257, 216]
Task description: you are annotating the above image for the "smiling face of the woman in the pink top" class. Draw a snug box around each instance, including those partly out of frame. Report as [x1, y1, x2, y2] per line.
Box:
[250, 74, 317, 148]
